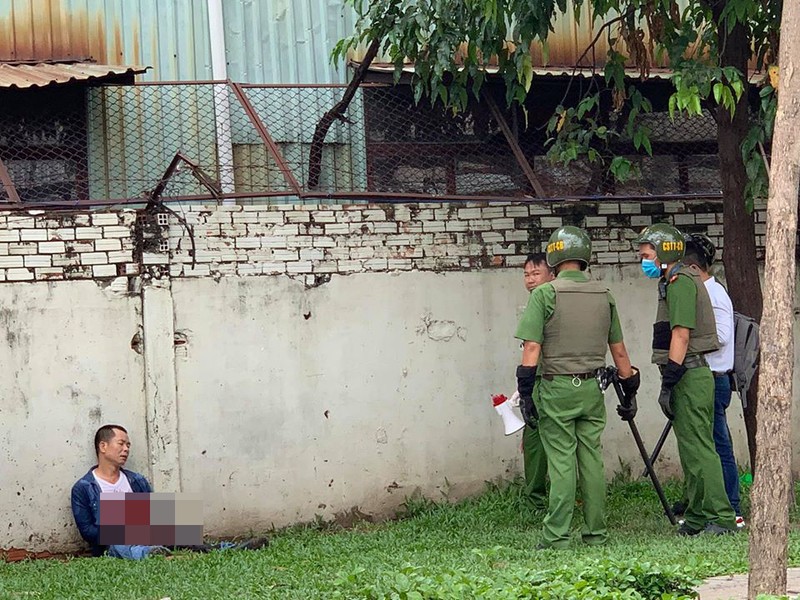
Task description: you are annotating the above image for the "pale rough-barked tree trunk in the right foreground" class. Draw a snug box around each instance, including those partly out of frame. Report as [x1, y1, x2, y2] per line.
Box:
[748, 0, 800, 600]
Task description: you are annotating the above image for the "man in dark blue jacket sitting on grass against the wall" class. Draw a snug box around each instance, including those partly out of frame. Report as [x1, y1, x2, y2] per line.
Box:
[72, 425, 269, 560]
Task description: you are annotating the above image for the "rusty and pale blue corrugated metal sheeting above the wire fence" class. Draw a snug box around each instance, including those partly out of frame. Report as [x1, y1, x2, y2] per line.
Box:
[0, 0, 732, 84]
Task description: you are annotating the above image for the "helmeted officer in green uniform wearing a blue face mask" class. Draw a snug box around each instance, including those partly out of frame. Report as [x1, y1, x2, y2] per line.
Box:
[634, 223, 736, 535]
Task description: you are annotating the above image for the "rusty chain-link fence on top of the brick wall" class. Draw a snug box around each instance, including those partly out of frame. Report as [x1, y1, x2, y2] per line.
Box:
[0, 82, 720, 205]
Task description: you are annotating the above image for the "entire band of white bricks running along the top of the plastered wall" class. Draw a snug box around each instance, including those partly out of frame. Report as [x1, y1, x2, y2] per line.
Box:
[0, 200, 744, 281]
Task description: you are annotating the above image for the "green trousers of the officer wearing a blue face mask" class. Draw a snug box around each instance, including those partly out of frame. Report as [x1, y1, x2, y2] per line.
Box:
[672, 367, 736, 530]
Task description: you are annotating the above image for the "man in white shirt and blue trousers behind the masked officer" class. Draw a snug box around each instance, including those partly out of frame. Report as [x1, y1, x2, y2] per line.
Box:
[683, 233, 744, 527]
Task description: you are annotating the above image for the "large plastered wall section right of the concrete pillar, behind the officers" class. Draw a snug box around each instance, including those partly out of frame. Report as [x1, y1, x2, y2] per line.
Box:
[167, 268, 747, 532]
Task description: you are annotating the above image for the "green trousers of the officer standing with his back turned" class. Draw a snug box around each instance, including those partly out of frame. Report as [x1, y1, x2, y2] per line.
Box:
[534, 375, 608, 548]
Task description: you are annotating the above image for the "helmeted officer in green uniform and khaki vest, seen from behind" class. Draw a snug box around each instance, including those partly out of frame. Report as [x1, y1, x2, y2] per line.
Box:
[516, 226, 639, 548]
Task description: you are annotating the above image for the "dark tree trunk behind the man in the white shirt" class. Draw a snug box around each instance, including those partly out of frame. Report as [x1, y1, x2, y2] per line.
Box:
[712, 8, 763, 472]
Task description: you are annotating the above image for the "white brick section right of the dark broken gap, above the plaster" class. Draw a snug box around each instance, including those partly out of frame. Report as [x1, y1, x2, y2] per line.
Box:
[158, 200, 736, 276]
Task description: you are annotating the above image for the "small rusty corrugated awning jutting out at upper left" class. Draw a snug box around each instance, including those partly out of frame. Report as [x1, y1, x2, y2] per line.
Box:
[0, 62, 149, 88]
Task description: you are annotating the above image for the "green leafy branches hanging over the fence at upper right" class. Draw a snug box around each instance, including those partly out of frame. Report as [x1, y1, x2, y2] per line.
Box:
[333, 0, 780, 201]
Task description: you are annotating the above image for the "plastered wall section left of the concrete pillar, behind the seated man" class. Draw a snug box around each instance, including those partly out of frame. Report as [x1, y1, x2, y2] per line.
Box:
[0, 281, 147, 549]
